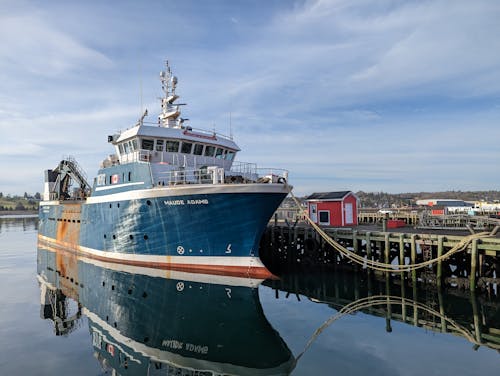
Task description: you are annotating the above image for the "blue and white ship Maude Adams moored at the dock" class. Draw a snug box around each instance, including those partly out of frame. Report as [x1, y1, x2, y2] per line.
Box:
[38, 61, 292, 278]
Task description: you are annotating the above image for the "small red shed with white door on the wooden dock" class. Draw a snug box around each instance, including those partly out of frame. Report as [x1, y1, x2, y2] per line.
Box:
[306, 191, 358, 227]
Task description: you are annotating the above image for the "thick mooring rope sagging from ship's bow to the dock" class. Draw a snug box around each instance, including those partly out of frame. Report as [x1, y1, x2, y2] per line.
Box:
[290, 191, 493, 273]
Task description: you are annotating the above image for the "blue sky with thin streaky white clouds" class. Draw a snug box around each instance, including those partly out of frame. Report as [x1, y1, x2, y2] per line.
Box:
[0, 0, 500, 195]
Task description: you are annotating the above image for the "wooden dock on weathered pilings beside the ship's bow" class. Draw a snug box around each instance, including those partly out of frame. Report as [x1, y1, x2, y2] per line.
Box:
[260, 225, 500, 294]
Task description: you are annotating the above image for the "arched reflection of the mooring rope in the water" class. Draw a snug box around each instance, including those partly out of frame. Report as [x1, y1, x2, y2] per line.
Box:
[295, 295, 500, 362]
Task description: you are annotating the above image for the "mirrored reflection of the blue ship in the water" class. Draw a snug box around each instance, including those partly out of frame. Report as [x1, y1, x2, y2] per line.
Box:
[38, 247, 295, 375]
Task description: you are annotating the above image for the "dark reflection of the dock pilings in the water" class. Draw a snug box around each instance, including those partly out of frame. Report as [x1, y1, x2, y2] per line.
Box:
[264, 271, 500, 352]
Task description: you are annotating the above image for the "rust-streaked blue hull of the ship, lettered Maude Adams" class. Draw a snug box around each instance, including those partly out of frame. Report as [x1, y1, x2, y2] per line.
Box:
[39, 184, 289, 278]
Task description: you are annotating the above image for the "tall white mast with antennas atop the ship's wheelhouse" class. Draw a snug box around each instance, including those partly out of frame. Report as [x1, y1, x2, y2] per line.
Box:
[158, 60, 181, 128]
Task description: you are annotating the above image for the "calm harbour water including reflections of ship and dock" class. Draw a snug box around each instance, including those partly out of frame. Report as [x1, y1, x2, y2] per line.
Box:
[0, 218, 500, 375]
